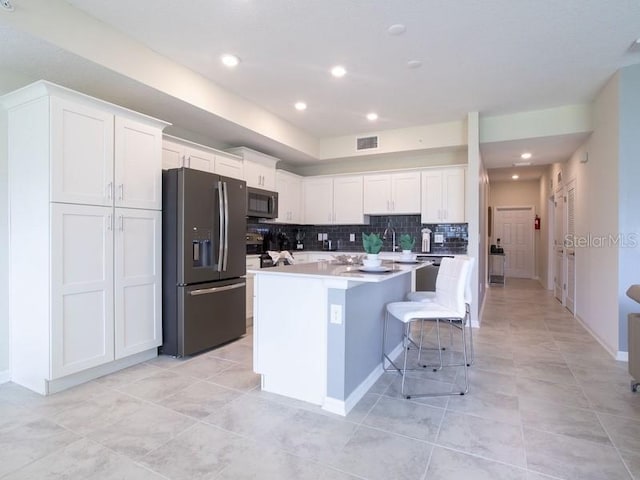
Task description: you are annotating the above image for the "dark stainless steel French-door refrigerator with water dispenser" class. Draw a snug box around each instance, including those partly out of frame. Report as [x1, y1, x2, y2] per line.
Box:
[160, 168, 247, 356]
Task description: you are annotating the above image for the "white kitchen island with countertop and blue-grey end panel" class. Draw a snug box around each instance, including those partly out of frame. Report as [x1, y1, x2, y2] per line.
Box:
[248, 262, 428, 415]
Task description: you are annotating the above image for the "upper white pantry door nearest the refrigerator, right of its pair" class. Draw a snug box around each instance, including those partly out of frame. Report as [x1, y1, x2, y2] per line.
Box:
[115, 117, 162, 210]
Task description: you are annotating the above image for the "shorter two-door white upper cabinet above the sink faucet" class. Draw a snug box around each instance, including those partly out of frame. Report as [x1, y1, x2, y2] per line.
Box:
[364, 171, 420, 215]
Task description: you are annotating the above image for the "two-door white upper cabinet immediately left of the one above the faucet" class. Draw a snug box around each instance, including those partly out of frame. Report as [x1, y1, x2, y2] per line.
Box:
[302, 175, 368, 225]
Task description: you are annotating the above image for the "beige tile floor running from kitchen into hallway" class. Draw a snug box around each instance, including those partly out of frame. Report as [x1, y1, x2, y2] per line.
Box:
[0, 280, 640, 480]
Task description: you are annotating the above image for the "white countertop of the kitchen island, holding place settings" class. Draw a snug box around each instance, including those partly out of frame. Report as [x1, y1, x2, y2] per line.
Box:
[247, 261, 430, 282]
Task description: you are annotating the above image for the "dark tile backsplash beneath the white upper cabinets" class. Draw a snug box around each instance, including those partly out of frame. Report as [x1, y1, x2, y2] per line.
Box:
[247, 215, 468, 254]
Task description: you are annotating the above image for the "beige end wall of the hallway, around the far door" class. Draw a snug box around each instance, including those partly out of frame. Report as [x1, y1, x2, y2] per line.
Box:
[489, 180, 546, 277]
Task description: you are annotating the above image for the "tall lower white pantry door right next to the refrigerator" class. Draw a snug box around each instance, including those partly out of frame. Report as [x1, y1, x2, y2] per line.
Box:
[114, 208, 162, 358]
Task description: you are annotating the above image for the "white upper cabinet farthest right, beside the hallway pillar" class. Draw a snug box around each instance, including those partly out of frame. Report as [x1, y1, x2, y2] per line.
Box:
[421, 167, 466, 223]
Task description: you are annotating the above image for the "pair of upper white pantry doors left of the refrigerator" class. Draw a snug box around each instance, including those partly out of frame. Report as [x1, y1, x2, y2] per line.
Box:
[50, 97, 162, 210]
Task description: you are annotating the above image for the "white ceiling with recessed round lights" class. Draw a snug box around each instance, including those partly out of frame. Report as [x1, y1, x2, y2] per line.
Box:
[0, 0, 640, 174]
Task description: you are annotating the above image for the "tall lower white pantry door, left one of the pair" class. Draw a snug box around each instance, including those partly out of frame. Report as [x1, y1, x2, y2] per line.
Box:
[51, 203, 114, 379]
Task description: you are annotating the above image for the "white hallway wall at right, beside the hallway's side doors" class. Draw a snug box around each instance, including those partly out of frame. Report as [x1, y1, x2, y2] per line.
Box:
[552, 73, 619, 355]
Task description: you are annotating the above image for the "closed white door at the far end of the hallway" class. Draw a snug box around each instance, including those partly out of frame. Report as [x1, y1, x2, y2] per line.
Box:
[495, 207, 535, 278]
